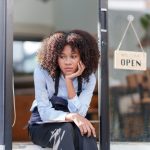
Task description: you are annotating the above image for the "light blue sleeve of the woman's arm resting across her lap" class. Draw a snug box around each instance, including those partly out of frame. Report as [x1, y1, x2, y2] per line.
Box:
[34, 67, 67, 122]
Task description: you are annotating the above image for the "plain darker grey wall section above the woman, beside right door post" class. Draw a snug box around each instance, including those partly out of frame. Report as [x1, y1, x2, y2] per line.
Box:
[54, 0, 98, 34]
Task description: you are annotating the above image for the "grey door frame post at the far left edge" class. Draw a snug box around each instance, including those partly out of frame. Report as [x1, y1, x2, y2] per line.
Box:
[0, 0, 13, 150]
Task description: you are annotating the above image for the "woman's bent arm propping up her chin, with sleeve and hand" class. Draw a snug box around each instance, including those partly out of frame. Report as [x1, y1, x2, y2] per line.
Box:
[65, 61, 96, 116]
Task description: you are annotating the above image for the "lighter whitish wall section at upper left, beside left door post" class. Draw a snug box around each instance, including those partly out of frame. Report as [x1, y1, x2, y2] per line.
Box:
[14, 0, 54, 36]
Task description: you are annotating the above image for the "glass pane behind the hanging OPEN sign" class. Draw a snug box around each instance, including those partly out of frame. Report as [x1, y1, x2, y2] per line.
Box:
[108, 0, 150, 146]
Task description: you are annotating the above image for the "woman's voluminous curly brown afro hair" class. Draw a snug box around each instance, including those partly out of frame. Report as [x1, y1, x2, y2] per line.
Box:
[37, 30, 100, 81]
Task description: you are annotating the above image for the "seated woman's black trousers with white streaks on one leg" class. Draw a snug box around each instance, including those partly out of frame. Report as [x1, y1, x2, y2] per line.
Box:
[29, 122, 97, 150]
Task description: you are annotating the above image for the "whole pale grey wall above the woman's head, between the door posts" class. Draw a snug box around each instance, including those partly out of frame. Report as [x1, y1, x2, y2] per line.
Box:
[14, 0, 98, 35]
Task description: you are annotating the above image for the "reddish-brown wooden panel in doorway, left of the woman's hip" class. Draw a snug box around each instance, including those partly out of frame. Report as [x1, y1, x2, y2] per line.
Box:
[12, 95, 34, 141]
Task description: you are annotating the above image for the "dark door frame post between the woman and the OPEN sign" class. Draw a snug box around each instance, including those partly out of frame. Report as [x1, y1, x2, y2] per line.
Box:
[98, 0, 110, 150]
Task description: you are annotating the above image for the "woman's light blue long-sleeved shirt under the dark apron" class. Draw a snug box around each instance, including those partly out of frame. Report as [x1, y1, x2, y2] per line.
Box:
[30, 65, 96, 122]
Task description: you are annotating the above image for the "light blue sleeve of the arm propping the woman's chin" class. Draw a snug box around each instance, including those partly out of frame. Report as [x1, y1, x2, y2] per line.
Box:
[68, 73, 96, 117]
